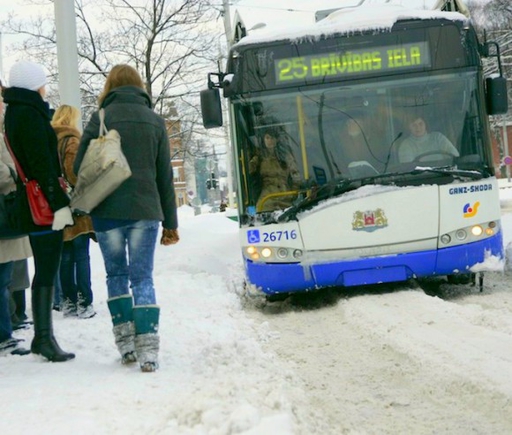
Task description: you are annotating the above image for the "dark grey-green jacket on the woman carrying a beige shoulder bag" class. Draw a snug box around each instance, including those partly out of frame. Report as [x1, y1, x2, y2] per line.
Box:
[74, 86, 178, 229]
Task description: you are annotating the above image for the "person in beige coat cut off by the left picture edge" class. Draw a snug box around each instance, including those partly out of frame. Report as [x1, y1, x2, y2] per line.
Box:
[0, 89, 32, 355]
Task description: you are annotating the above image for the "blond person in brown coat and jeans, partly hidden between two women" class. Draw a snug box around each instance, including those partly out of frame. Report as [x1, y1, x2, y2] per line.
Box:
[51, 104, 96, 319]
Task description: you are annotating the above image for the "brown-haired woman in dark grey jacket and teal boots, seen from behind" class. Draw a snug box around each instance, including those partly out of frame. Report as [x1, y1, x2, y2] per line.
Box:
[74, 65, 179, 372]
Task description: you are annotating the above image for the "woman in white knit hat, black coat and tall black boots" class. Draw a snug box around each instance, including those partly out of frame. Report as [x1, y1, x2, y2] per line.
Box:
[4, 60, 75, 362]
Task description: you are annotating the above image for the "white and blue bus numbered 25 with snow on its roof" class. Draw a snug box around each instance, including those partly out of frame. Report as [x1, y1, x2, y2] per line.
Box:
[203, 5, 506, 294]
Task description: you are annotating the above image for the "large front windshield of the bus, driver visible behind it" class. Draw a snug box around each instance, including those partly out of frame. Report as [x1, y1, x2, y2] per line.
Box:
[233, 69, 491, 215]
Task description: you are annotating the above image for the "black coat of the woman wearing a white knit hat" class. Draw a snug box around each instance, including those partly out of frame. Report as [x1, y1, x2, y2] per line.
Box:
[4, 88, 69, 232]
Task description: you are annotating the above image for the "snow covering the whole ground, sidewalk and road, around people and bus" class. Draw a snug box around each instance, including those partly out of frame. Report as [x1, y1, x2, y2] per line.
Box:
[0, 189, 512, 435]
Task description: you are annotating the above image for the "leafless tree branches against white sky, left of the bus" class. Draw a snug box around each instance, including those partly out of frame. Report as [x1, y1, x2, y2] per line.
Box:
[1, 0, 223, 164]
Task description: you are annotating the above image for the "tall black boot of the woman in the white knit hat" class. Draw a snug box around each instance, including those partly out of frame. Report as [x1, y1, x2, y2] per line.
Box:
[30, 287, 75, 362]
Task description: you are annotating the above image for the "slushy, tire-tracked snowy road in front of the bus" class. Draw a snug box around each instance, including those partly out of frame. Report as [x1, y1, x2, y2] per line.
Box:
[243, 274, 512, 435]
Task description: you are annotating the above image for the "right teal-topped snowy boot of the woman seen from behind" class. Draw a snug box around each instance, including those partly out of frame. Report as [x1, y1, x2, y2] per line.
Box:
[133, 305, 160, 372]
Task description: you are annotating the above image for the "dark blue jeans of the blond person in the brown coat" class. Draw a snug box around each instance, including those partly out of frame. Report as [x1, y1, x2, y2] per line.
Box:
[60, 234, 93, 307]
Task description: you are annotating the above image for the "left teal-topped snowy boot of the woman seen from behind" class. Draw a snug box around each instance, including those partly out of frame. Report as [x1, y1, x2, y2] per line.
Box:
[107, 295, 137, 364]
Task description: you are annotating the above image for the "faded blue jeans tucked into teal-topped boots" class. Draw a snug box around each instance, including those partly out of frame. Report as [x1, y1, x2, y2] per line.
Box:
[96, 220, 160, 305]
